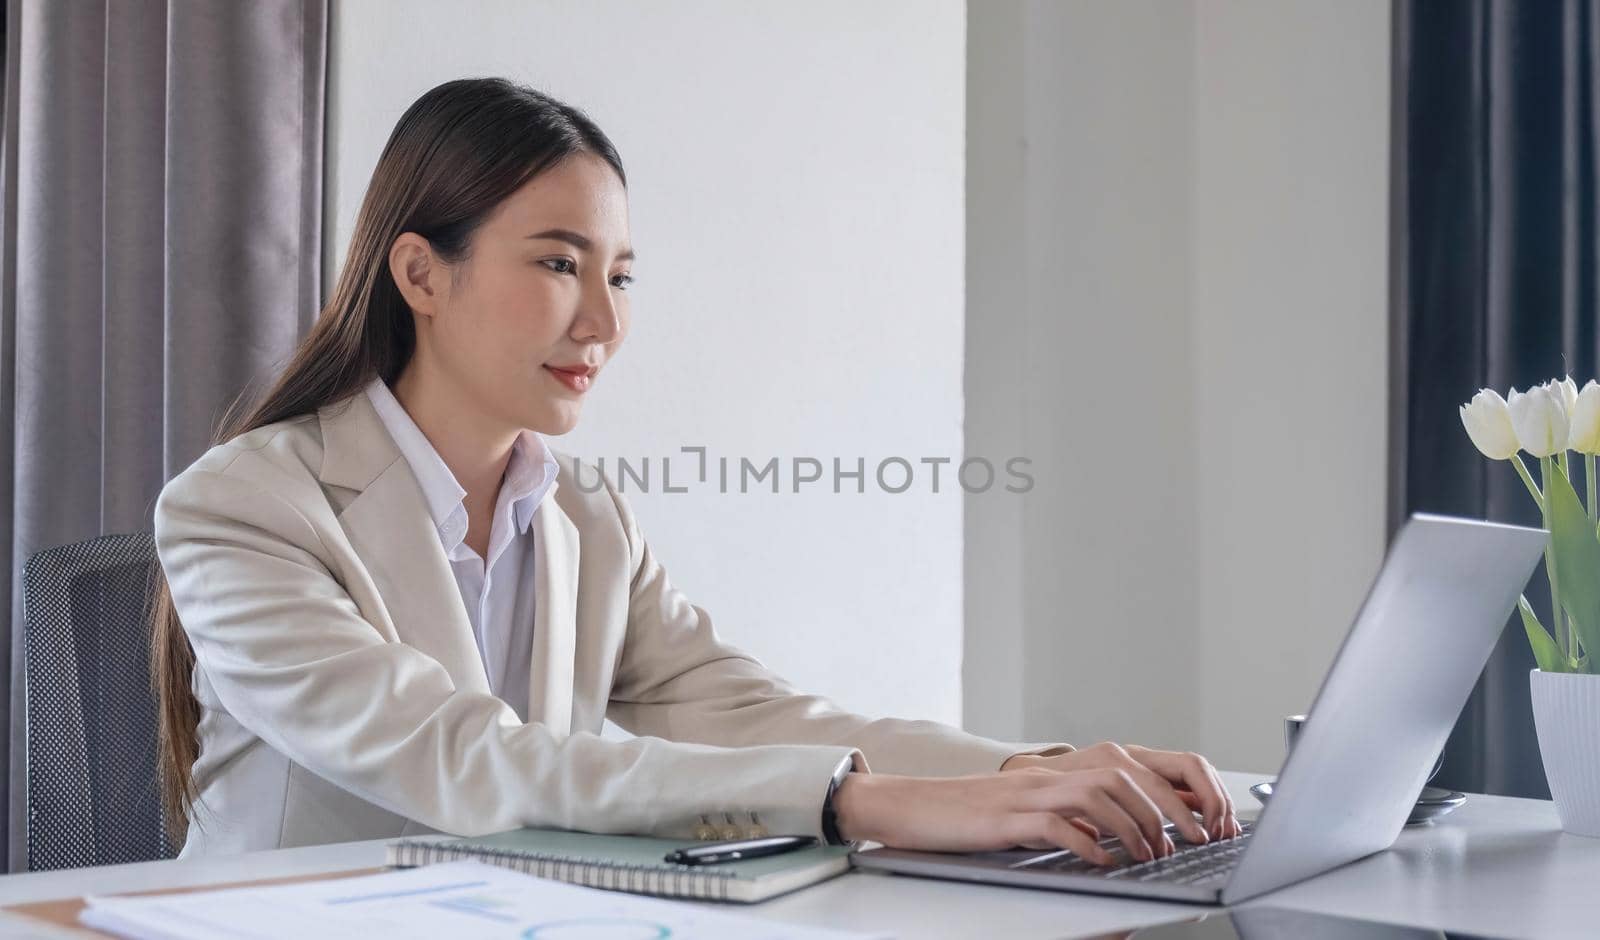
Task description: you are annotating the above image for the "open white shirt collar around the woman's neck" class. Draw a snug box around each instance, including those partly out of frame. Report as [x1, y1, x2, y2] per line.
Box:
[366, 377, 558, 547]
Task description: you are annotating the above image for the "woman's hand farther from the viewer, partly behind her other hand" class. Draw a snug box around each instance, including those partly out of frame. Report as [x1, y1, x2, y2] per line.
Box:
[1000, 742, 1243, 841]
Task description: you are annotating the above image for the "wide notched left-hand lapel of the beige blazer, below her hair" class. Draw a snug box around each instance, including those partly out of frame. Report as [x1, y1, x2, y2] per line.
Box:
[318, 392, 486, 692]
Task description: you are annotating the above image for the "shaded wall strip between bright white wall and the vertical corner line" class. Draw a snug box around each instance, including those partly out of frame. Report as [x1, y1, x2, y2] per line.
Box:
[966, 3, 1195, 747]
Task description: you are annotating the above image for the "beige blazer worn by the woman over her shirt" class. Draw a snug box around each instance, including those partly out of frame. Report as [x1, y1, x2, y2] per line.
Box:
[155, 385, 1070, 857]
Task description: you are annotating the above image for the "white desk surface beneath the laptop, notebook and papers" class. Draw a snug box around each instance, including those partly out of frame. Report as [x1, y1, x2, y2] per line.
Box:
[0, 772, 1600, 940]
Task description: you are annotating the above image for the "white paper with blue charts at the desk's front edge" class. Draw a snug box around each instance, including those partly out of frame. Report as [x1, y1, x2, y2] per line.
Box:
[80, 862, 886, 940]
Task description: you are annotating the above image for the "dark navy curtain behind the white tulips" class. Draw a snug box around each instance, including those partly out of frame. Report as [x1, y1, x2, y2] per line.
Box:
[1389, 0, 1600, 798]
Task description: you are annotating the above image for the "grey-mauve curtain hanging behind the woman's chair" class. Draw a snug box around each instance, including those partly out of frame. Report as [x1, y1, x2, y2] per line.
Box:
[0, 0, 328, 871]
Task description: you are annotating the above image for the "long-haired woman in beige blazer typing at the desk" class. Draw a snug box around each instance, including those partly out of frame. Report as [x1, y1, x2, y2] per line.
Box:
[152, 78, 1238, 860]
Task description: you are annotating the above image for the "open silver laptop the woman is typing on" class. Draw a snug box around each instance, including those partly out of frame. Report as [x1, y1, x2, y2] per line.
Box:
[851, 513, 1547, 905]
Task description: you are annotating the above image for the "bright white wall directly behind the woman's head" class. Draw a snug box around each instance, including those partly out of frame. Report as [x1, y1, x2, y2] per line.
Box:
[328, 0, 965, 723]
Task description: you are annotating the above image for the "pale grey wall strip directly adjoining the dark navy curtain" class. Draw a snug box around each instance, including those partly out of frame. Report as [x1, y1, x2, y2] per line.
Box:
[1194, 0, 1389, 769]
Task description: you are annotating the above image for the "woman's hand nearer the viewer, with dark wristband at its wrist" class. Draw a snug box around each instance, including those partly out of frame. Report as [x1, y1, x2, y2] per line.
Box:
[834, 767, 1205, 865]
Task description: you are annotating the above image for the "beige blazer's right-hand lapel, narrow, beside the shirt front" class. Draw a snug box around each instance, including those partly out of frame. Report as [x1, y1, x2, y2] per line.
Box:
[528, 480, 578, 737]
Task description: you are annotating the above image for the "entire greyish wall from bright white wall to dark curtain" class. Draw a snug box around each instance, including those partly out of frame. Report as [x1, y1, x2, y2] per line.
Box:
[965, 0, 1389, 771]
